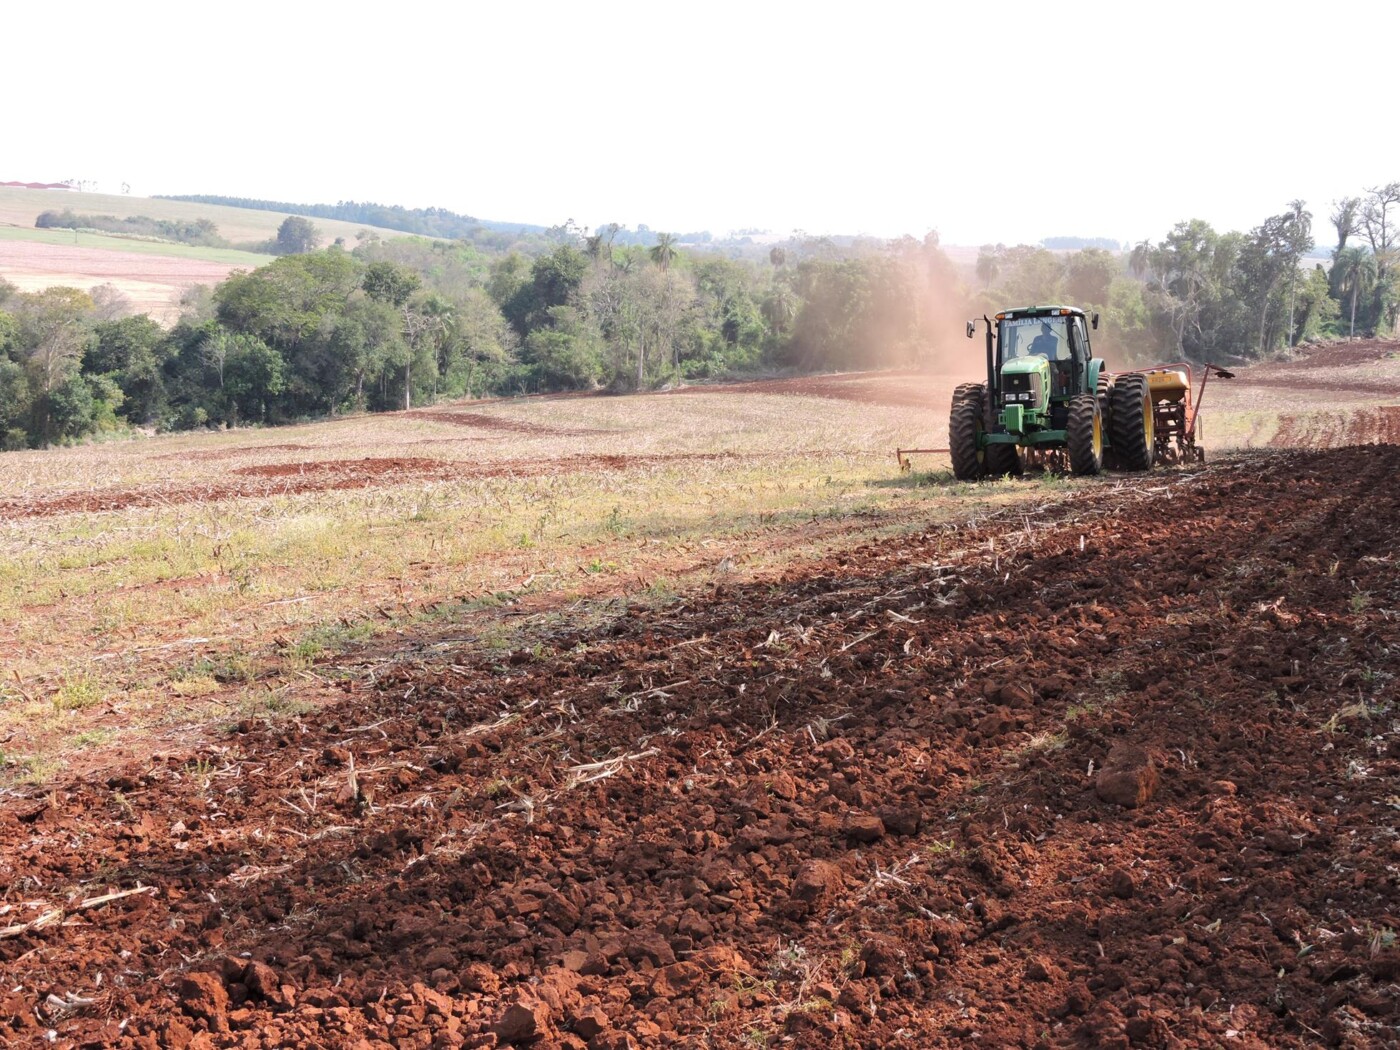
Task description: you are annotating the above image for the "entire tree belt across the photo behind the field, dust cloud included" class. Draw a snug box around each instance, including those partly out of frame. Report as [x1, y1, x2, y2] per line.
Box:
[0, 183, 1400, 448]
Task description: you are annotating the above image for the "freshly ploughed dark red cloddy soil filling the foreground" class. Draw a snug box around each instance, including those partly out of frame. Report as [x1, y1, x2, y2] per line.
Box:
[0, 448, 1400, 1047]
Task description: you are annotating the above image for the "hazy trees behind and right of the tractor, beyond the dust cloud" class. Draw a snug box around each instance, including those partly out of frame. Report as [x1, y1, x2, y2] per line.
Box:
[976, 182, 1400, 361]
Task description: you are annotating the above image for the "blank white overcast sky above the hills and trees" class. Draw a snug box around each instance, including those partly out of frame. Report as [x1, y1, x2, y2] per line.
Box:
[0, 0, 1400, 244]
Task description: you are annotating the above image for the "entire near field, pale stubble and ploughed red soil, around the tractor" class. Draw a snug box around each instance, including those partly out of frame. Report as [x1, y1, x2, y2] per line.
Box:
[0, 342, 1400, 1050]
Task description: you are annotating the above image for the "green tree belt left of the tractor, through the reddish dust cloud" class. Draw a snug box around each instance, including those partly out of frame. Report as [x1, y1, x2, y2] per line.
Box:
[0, 230, 956, 448]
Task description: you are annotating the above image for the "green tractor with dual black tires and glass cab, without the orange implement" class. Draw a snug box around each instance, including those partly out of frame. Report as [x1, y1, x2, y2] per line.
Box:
[948, 307, 1158, 482]
